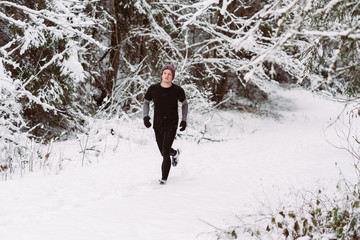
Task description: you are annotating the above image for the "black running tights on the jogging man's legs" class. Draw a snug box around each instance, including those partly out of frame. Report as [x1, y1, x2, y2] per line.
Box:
[155, 128, 176, 180]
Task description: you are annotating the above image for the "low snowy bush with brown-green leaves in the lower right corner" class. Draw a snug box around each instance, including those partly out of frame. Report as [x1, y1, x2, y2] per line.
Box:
[208, 180, 360, 240]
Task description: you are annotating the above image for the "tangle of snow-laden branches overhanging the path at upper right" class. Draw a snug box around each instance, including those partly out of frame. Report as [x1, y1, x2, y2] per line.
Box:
[159, 0, 360, 100]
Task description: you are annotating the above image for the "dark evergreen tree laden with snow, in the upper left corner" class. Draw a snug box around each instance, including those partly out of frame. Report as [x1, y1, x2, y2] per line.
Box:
[0, 0, 104, 140]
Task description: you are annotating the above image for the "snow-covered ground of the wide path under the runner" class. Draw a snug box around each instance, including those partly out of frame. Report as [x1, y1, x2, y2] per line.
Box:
[0, 85, 355, 240]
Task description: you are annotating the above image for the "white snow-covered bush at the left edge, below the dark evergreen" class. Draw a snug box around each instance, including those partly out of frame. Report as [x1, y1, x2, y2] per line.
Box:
[0, 62, 42, 180]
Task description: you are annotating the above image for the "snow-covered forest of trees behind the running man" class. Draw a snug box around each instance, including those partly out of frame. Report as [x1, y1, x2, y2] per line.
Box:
[0, 0, 360, 239]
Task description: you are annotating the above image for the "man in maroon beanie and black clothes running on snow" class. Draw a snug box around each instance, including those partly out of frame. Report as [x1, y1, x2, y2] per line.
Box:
[143, 64, 188, 184]
